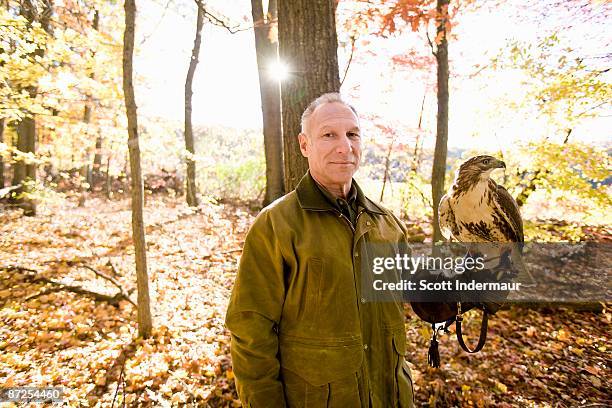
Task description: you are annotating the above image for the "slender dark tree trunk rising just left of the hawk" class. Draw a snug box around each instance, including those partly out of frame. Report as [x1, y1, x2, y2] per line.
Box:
[431, 0, 449, 242]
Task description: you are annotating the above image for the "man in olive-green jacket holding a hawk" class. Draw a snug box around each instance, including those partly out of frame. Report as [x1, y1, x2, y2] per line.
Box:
[226, 93, 413, 408]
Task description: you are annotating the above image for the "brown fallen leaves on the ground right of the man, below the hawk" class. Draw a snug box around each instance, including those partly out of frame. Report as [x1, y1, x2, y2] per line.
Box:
[408, 307, 611, 407]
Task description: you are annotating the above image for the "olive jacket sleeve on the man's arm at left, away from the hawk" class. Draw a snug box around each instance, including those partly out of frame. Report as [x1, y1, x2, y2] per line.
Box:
[225, 212, 286, 408]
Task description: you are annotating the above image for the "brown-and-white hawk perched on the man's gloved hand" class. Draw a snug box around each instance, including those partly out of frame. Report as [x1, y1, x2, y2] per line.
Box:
[438, 155, 525, 269]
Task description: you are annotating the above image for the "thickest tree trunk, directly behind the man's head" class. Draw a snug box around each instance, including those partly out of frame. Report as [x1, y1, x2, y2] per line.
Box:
[278, 0, 340, 192]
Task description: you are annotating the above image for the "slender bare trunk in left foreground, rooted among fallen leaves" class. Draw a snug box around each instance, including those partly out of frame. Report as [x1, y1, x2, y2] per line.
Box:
[123, 0, 153, 338]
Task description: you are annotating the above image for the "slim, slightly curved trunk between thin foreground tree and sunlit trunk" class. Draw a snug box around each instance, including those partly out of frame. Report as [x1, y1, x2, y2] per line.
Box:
[185, 1, 204, 207]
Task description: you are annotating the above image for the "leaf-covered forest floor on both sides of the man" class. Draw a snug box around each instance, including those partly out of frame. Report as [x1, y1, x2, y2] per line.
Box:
[0, 195, 612, 407]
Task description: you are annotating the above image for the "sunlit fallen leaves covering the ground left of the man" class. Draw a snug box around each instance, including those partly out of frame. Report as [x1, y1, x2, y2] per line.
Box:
[0, 197, 252, 406]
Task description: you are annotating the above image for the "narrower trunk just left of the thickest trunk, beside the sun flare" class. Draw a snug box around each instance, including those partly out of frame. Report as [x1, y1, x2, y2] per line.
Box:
[251, 0, 284, 206]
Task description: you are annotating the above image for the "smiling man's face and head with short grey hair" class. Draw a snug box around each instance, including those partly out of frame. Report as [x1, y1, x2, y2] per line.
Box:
[299, 102, 361, 187]
